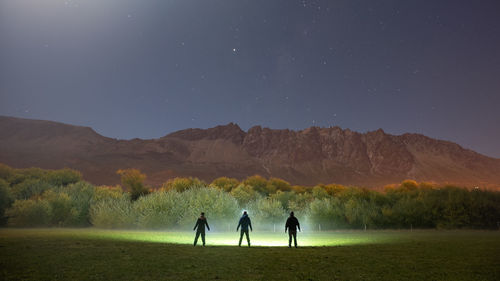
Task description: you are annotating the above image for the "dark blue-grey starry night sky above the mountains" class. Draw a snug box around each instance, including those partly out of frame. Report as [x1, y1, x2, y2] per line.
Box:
[0, 0, 500, 158]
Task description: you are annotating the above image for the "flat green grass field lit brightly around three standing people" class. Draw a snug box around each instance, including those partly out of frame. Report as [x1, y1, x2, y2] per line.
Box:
[0, 229, 500, 280]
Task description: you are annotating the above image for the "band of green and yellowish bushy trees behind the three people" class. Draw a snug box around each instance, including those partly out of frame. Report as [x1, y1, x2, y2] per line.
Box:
[0, 164, 500, 230]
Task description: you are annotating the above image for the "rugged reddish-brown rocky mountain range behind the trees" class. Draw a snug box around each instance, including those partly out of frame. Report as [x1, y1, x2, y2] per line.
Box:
[0, 116, 500, 188]
